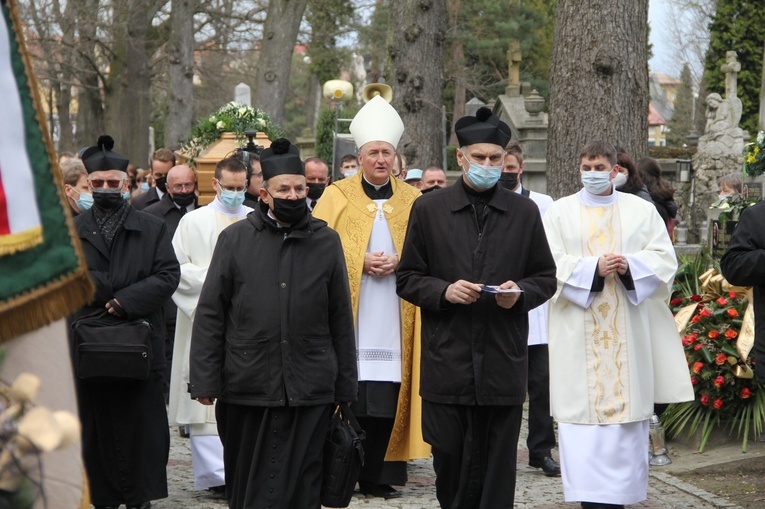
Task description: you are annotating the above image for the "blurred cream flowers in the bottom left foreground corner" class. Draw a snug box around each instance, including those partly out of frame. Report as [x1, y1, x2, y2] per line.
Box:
[0, 360, 80, 508]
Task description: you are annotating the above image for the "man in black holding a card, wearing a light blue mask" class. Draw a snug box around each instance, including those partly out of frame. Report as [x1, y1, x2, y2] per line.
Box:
[396, 108, 556, 508]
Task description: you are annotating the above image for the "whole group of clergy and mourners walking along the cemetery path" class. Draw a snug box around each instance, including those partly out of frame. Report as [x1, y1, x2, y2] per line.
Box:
[60, 97, 765, 509]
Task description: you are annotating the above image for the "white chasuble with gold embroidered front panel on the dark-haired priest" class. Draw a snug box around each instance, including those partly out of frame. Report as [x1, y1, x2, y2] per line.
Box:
[543, 191, 693, 424]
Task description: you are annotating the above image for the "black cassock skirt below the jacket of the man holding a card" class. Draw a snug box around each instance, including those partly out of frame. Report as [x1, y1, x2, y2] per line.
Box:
[422, 400, 523, 509]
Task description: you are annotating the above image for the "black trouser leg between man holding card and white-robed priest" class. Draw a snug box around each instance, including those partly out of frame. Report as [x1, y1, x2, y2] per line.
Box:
[526, 345, 555, 460]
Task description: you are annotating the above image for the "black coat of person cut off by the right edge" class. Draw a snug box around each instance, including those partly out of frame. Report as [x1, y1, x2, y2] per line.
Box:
[720, 202, 765, 383]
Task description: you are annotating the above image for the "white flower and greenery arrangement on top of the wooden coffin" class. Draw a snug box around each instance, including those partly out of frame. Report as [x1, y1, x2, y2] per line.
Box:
[181, 101, 282, 162]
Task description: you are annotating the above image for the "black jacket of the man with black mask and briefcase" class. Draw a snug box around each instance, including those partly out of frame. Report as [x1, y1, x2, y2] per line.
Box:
[189, 207, 358, 406]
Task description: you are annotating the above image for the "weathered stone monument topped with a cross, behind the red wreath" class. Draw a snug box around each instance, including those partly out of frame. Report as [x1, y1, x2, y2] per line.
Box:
[684, 51, 744, 240]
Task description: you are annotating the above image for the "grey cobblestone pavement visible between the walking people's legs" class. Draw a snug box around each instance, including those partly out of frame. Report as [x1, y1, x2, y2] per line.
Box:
[153, 404, 740, 509]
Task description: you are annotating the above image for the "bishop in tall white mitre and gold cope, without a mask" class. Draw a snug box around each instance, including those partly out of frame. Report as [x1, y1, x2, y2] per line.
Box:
[313, 96, 429, 498]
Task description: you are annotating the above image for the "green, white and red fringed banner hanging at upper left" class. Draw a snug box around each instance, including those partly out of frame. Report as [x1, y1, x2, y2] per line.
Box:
[0, 0, 93, 342]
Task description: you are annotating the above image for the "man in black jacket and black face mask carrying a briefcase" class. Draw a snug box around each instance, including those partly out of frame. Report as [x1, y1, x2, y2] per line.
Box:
[191, 138, 357, 509]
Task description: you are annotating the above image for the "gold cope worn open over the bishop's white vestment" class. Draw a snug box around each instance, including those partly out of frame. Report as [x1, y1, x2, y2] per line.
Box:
[313, 171, 430, 461]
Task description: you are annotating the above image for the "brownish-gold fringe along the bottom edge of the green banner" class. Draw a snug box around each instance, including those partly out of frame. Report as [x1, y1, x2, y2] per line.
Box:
[0, 271, 93, 343]
